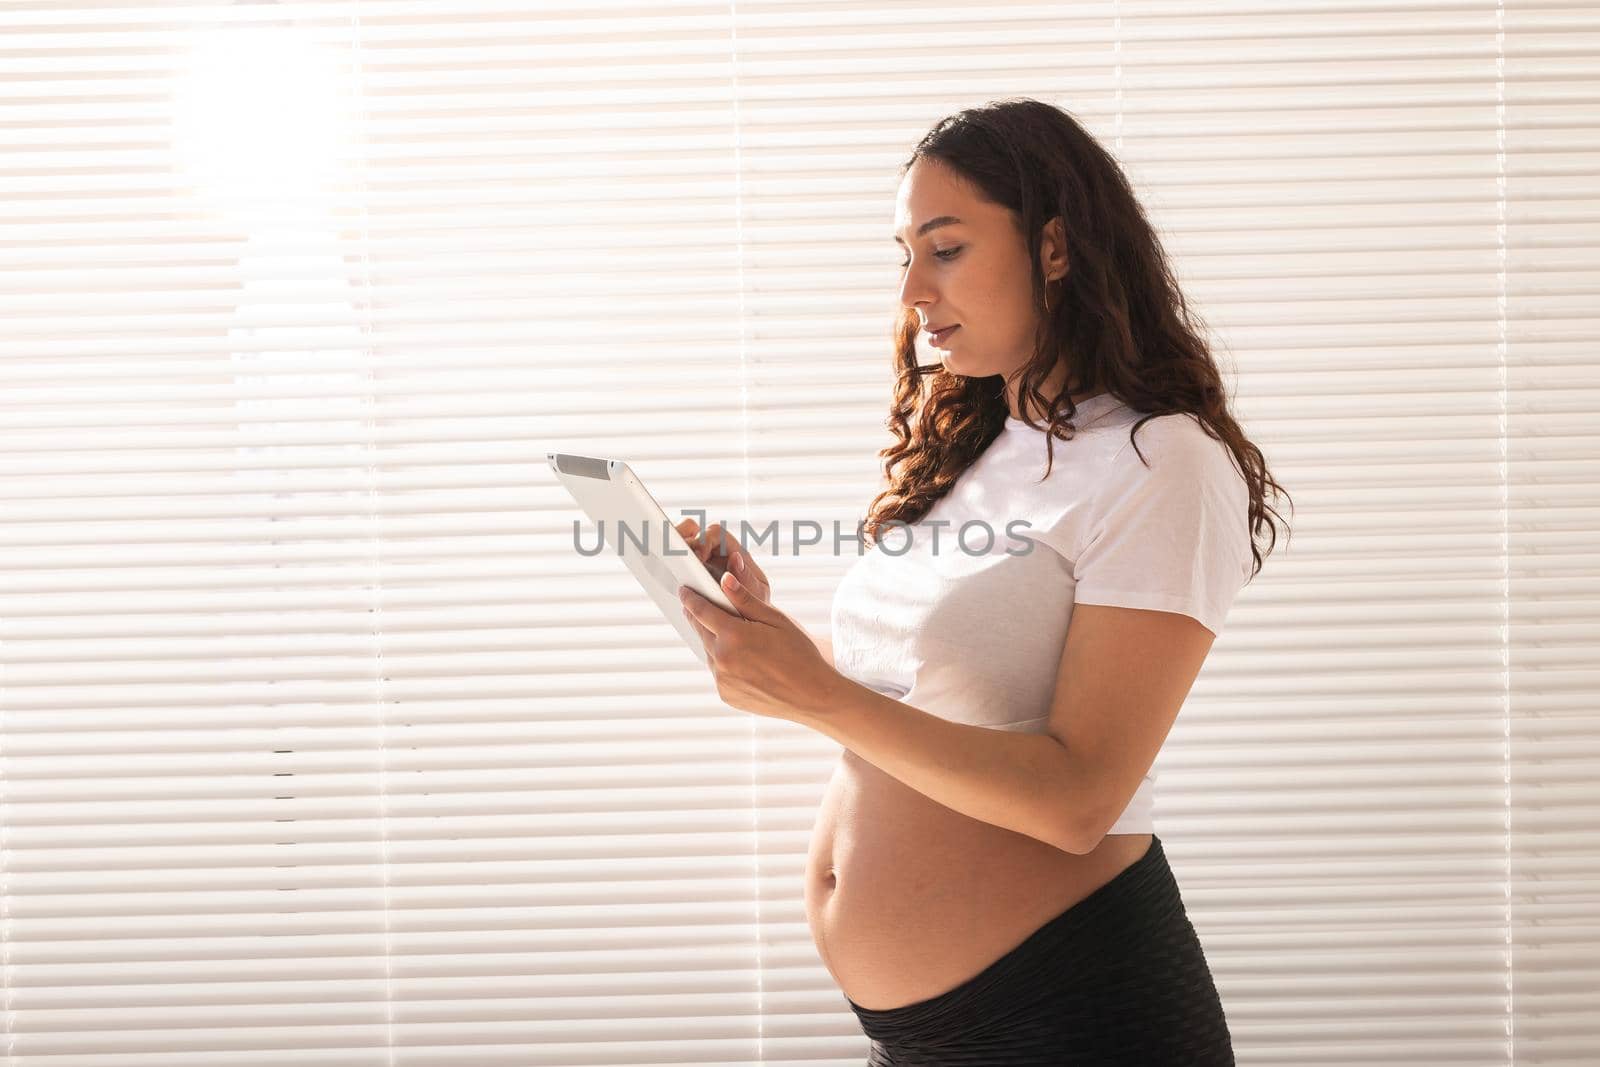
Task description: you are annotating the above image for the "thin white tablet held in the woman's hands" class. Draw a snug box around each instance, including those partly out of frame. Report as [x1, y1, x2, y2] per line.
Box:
[546, 453, 744, 664]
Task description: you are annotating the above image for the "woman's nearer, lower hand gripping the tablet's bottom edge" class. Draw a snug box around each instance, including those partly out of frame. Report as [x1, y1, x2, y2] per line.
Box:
[678, 573, 842, 721]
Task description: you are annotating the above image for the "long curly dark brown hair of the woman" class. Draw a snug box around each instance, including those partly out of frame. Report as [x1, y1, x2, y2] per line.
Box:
[861, 98, 1286, 577]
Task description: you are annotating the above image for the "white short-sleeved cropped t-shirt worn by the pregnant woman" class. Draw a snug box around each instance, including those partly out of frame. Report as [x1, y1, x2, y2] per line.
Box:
[830, 392, 1253, 833]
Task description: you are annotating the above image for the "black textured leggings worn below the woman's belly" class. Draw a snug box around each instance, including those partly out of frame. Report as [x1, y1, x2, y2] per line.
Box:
[846, 835, 1234, 1067]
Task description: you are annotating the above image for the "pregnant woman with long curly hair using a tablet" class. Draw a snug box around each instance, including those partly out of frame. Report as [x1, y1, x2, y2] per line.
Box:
[680, 99, 1282, 1067]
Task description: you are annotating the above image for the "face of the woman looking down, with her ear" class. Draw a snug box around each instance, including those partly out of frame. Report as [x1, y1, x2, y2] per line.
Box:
[894, 158, 1067, 388]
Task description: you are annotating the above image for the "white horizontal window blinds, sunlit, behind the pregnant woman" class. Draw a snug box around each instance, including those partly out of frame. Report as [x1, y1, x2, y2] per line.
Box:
[0, 0, 1600, 1067]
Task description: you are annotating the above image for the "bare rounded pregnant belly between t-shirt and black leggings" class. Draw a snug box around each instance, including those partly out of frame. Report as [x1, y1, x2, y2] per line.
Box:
[805, 749, 1150, 1011]
